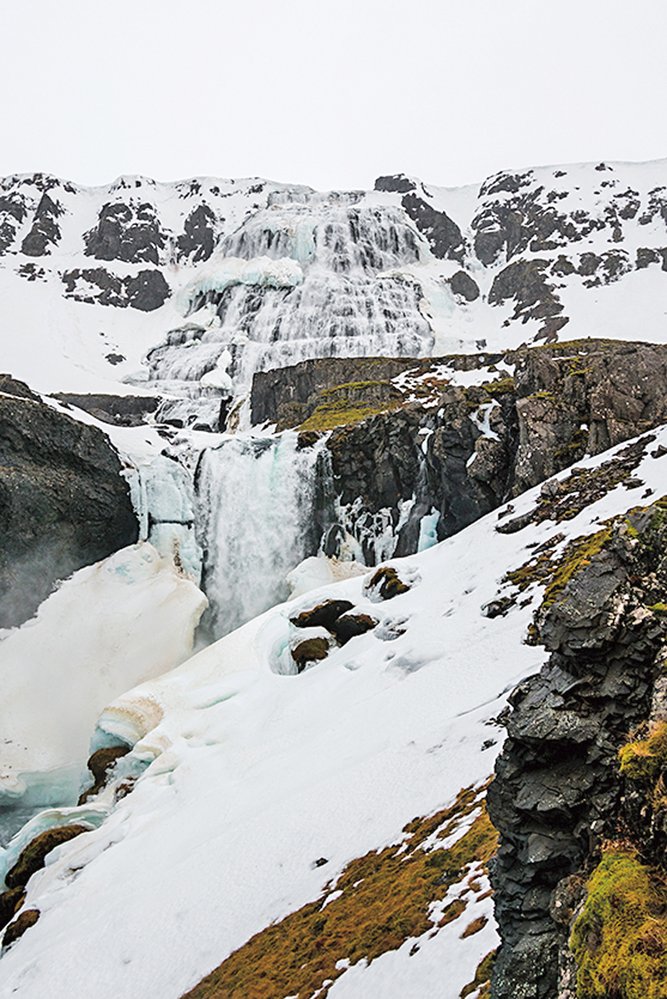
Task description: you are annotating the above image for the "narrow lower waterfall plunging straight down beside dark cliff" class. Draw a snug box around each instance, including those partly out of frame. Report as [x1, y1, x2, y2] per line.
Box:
[196, 433, 330, 638]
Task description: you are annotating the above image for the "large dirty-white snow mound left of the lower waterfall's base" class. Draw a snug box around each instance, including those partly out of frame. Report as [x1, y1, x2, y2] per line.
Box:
[0, 544, 206, 820]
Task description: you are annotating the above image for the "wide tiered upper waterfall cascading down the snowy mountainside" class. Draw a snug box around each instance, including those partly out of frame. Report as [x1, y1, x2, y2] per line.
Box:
[148, 191, 434, 428]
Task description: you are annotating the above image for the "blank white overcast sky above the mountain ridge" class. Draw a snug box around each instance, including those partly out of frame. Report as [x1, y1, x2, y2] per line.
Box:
[0, 0, 667, 188]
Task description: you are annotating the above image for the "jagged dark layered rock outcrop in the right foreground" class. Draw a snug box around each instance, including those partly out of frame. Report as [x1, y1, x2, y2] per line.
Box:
[488, 504, 667, 999]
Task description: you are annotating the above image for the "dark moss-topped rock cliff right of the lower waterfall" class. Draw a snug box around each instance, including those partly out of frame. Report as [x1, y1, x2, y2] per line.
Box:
[258, 340, 667, 564]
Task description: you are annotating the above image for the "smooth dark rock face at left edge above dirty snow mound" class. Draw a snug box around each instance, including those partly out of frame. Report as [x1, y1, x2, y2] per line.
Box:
[0, 379, 138, 628]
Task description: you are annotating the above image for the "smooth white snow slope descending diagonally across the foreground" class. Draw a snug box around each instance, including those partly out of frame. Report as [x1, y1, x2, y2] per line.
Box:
[0, 429, 667, 999]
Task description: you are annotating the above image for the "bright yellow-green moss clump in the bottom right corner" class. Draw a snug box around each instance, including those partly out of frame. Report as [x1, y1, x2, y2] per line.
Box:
[570, 848, 667, 999]
